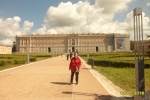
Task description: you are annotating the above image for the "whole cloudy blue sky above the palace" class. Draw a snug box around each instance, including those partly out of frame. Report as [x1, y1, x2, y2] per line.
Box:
[0, 0, 150, 45]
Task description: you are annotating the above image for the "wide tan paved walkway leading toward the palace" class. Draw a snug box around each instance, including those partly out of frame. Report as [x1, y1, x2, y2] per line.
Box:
[0, 57, 136, 100]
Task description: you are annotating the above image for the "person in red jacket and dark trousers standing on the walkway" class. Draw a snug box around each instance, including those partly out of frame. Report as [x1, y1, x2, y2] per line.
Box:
[69, 52, 81, 85]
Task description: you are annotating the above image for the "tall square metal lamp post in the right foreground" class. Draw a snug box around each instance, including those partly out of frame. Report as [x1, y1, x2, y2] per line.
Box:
[133, 8, 145, 100]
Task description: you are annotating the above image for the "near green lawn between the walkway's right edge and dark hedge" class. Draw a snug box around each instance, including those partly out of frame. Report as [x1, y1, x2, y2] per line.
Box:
[94, 66, 150, 91]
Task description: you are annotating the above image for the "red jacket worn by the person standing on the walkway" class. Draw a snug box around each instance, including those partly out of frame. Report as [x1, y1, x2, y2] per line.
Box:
[69, 57, 81, 72]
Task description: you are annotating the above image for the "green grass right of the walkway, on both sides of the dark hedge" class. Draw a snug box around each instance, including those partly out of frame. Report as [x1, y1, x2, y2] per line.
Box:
[80, 52, 150, 91]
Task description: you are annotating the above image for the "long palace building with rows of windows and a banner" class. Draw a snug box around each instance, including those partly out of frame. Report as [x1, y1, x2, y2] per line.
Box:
[16, 33, 130, 53]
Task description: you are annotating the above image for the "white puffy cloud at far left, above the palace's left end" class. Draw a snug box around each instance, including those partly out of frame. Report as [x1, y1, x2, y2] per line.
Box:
[0, 16, 34, 44]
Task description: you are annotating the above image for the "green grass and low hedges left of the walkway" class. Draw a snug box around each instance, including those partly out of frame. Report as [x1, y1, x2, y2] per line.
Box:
[0, 54, 52, 70]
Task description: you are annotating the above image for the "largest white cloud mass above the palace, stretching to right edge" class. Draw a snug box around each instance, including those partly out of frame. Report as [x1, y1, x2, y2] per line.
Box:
[34, 0, 150, 39]
